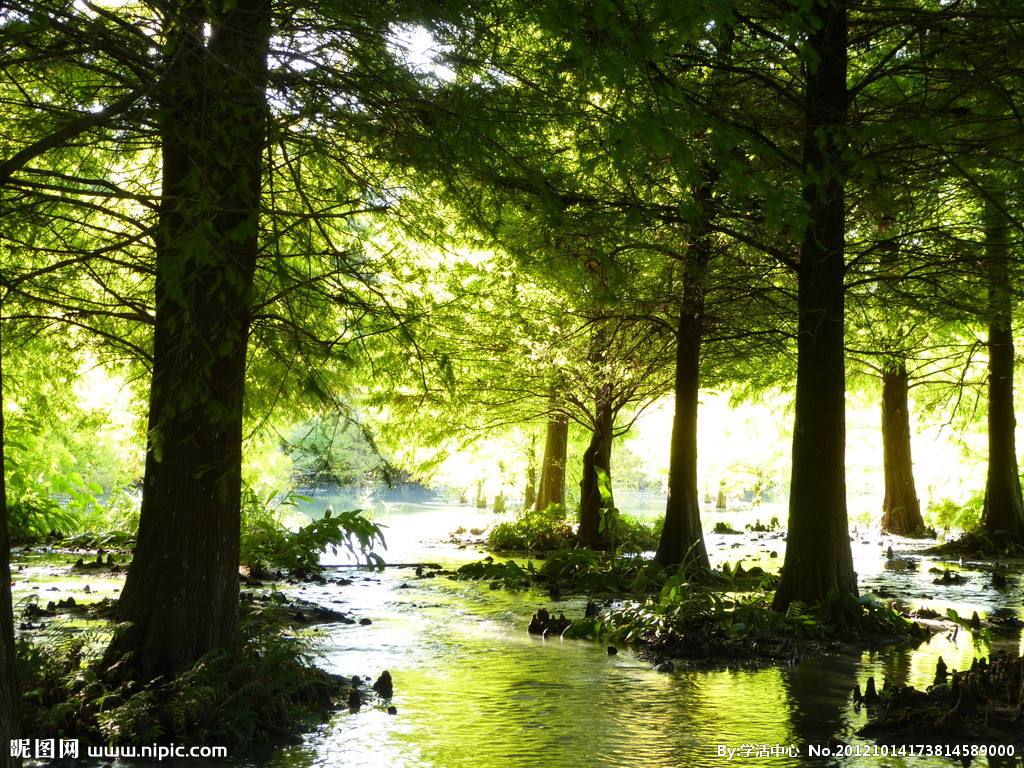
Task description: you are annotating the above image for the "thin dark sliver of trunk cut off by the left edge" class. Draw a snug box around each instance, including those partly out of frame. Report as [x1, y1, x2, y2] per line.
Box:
[0, 321, 19, 768]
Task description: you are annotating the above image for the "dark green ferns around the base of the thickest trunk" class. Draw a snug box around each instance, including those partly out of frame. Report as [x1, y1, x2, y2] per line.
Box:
[17, 613, 344, 745]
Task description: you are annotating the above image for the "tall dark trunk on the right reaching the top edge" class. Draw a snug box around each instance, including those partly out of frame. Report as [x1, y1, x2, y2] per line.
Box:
[774, 0, 857, 610]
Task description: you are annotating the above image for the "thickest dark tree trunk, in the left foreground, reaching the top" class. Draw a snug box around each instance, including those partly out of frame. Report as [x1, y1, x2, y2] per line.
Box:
[105, 0, 270, 680]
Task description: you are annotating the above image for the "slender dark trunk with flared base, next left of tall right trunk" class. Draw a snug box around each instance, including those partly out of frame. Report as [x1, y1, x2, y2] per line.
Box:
[654, 262, 711, 570]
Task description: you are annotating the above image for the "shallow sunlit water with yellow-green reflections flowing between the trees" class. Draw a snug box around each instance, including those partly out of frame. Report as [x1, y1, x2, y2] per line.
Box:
[9, 498, 1021, 768]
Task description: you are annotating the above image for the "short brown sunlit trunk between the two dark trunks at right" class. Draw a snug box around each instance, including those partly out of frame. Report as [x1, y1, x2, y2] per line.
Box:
[882, 362, 925, 536]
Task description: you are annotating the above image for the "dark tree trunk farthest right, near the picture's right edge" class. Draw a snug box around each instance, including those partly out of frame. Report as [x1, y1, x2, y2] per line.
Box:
[981, 195, 1024, 542]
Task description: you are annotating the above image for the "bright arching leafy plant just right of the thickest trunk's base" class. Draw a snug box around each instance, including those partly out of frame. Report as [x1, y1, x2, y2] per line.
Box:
[242, 488, 386, 578]
